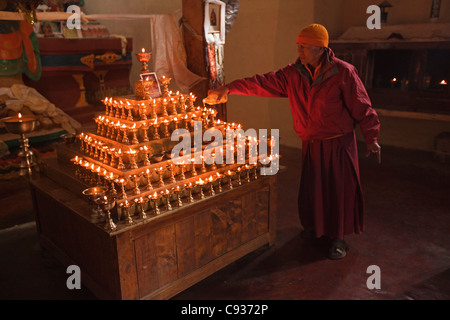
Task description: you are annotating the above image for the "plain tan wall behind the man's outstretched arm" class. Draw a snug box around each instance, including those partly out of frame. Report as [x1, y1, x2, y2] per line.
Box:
[225, 0, 314, 147]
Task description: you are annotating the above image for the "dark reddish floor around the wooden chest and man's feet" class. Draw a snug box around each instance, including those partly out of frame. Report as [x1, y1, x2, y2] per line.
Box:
[0, 142, 450, 300]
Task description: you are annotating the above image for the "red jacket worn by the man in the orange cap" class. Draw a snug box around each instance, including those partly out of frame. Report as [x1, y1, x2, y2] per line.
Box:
[227, 49, 380, 144]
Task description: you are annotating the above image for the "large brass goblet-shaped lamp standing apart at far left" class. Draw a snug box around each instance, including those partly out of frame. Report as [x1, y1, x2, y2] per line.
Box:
[2, 113, 37, 176]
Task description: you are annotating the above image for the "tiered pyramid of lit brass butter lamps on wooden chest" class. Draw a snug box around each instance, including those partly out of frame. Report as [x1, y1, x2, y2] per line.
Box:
[71, 70, 278, 232]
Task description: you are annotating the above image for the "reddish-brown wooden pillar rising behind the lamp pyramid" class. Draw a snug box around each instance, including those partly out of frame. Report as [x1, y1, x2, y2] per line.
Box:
[182, 0, 226, 121]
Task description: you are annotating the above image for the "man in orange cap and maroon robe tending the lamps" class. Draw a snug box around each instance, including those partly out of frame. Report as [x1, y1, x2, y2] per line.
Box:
[206, 24, 381, 259]
